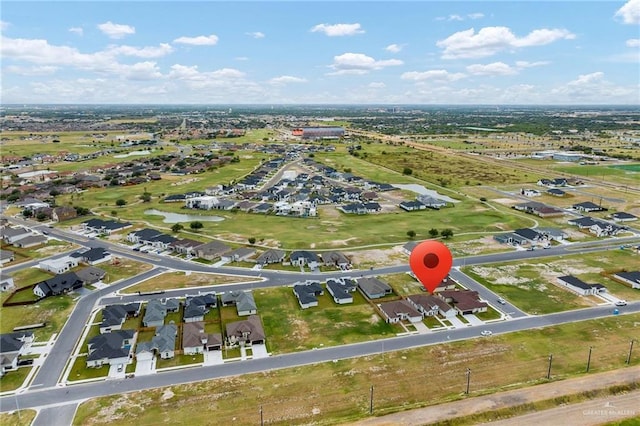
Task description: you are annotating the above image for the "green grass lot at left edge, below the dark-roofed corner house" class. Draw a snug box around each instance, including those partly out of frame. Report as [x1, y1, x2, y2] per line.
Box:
[0, 296, 74, 342]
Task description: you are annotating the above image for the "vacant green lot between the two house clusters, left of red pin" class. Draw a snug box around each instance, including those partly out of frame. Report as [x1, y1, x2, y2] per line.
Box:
[255, 287, 403, 353]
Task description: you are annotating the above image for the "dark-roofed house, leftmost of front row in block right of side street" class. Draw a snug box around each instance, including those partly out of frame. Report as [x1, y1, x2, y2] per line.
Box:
[87, 330, 137, 367]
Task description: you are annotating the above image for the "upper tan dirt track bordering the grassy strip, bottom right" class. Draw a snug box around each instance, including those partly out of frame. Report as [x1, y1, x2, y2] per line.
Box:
[350, 366, 640, 426]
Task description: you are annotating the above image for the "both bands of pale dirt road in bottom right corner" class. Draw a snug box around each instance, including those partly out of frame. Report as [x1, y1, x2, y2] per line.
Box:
[352, 366, 640, 426]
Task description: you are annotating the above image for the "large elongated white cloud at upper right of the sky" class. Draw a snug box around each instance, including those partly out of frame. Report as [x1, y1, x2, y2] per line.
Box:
[436, 27, 575, 59]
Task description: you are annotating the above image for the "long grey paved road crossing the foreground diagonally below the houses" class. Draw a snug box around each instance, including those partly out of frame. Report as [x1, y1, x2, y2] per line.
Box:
[0, 302, 640, 412]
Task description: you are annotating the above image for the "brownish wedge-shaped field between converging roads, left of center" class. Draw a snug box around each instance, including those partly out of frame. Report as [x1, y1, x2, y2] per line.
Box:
[120, 272, 255, 294]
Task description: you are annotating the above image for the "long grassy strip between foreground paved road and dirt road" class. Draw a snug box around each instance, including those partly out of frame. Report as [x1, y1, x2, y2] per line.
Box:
[74, 314, 640, 425]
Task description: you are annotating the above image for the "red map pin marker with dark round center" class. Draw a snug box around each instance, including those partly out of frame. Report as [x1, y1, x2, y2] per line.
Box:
[409, 241, 453, 294]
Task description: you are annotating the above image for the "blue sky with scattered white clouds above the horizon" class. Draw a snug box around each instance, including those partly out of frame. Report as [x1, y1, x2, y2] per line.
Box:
[0, 0, 640, 105]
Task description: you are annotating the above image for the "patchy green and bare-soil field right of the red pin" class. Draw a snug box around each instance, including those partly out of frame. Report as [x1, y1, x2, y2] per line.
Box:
[463, 250, 640, 314]
